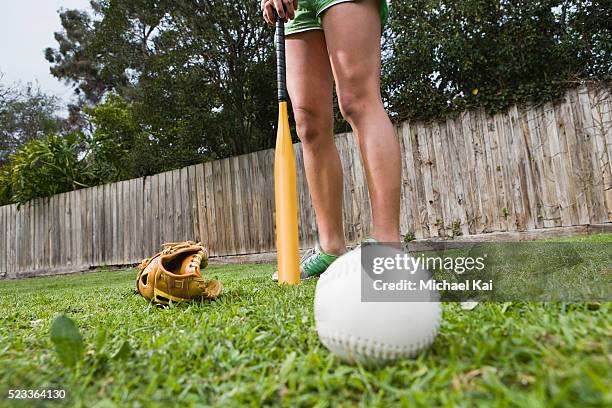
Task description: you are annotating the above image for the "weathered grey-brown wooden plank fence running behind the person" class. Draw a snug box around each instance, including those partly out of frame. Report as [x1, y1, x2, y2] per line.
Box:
[0, 87, 612, 277]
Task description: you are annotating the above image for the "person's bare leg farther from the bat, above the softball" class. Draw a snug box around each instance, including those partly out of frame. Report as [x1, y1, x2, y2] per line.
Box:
[322, 0, 401, 242]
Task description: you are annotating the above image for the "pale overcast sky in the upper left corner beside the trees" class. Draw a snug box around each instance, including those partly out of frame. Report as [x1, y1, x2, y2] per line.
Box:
[0, 0, 89, 105]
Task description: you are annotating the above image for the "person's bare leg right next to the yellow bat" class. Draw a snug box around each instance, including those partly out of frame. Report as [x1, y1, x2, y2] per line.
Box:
[286, 30, 346, 255]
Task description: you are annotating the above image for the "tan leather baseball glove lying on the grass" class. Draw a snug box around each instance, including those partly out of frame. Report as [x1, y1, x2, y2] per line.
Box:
[136, 241, 221, 305]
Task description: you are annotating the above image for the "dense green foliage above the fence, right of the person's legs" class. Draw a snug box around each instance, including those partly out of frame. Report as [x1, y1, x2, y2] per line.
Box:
[383, 0, 612, 120]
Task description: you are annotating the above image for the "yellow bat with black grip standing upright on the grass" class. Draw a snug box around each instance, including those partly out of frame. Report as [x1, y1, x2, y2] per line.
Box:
[274, 11, 300, 285]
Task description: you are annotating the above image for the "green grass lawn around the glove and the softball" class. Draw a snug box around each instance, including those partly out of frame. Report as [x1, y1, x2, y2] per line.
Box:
[0, 235, 612, 408]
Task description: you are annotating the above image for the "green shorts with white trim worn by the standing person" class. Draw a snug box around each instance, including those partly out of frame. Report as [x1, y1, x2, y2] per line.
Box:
[285, 0, 389, 35]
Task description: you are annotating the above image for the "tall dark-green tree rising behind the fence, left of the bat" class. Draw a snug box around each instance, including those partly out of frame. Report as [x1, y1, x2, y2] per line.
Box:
[47, 0, 276, 174]
